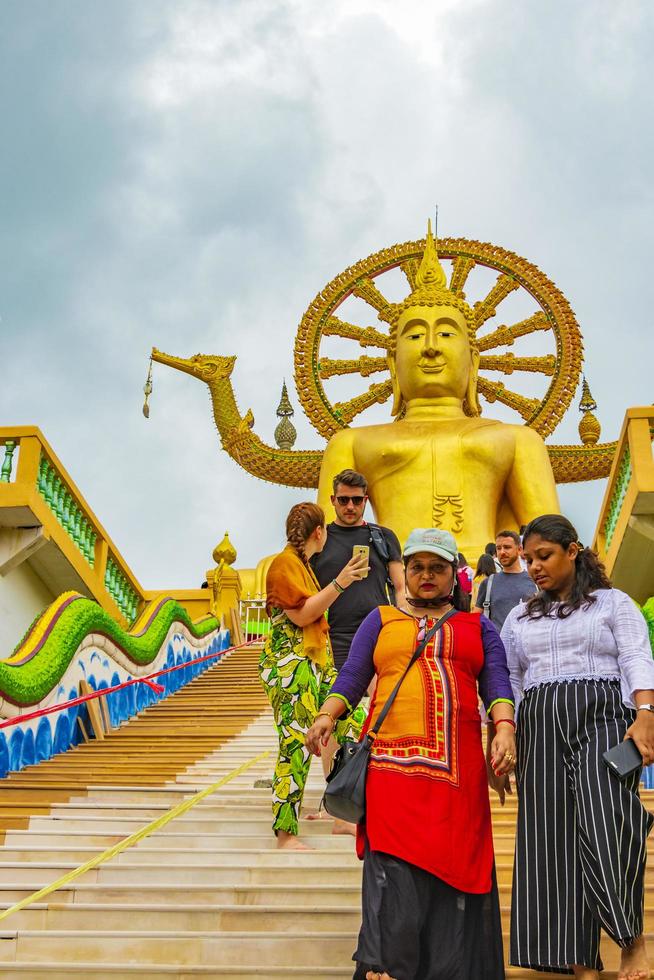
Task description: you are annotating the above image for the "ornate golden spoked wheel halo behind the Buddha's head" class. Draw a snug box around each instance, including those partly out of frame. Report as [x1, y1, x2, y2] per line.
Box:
[295, 238, 583, 439]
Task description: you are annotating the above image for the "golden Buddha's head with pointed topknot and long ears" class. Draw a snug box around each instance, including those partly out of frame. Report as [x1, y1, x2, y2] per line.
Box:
[388, 223, 481, 417]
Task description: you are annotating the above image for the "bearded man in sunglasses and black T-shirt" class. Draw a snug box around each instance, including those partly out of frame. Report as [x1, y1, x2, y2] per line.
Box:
[311, 470, 404, 670]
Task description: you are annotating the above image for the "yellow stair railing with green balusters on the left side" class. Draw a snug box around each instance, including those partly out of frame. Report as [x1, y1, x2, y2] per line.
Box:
[0, 426, 145, 623]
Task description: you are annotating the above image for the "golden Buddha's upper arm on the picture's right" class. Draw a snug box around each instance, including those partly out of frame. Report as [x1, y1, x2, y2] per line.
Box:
[506, 426, 560, 525]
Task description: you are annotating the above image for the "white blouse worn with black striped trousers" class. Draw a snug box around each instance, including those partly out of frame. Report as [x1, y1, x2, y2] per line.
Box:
[502, 589, 654, 708]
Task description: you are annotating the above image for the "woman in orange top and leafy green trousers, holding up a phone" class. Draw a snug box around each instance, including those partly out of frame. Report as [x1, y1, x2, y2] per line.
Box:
[259, 503, 368, 849]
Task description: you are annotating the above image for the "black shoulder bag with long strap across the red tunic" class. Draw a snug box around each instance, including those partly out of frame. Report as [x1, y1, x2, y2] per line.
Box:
[322, 609, 457, 823]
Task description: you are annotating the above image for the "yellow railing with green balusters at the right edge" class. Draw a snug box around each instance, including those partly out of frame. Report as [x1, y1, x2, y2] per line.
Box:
[593, 405, 654, 603]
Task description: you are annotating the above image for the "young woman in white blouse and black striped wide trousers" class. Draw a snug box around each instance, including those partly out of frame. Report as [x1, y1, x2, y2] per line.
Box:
[502, 514, 654, 980]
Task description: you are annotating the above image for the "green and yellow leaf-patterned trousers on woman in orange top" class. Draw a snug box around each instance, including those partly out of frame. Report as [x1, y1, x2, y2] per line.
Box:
[259, 617, 366, 834]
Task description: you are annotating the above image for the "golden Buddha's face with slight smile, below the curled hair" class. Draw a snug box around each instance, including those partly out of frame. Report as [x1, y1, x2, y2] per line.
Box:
[395, 306, 472, 401]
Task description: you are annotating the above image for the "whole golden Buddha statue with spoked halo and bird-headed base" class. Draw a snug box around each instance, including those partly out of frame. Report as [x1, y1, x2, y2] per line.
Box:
[152, 220, 616, 568]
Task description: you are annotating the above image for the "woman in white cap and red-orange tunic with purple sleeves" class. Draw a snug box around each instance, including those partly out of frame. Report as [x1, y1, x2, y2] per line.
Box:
[307, 528, 515, 980]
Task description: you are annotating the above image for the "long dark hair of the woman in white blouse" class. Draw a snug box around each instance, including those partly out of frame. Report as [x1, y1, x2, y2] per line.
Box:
[521, 514, 612, 619]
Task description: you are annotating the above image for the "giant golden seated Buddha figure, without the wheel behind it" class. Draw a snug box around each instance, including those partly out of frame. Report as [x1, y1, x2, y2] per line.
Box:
[318, 225, 559, 561]
